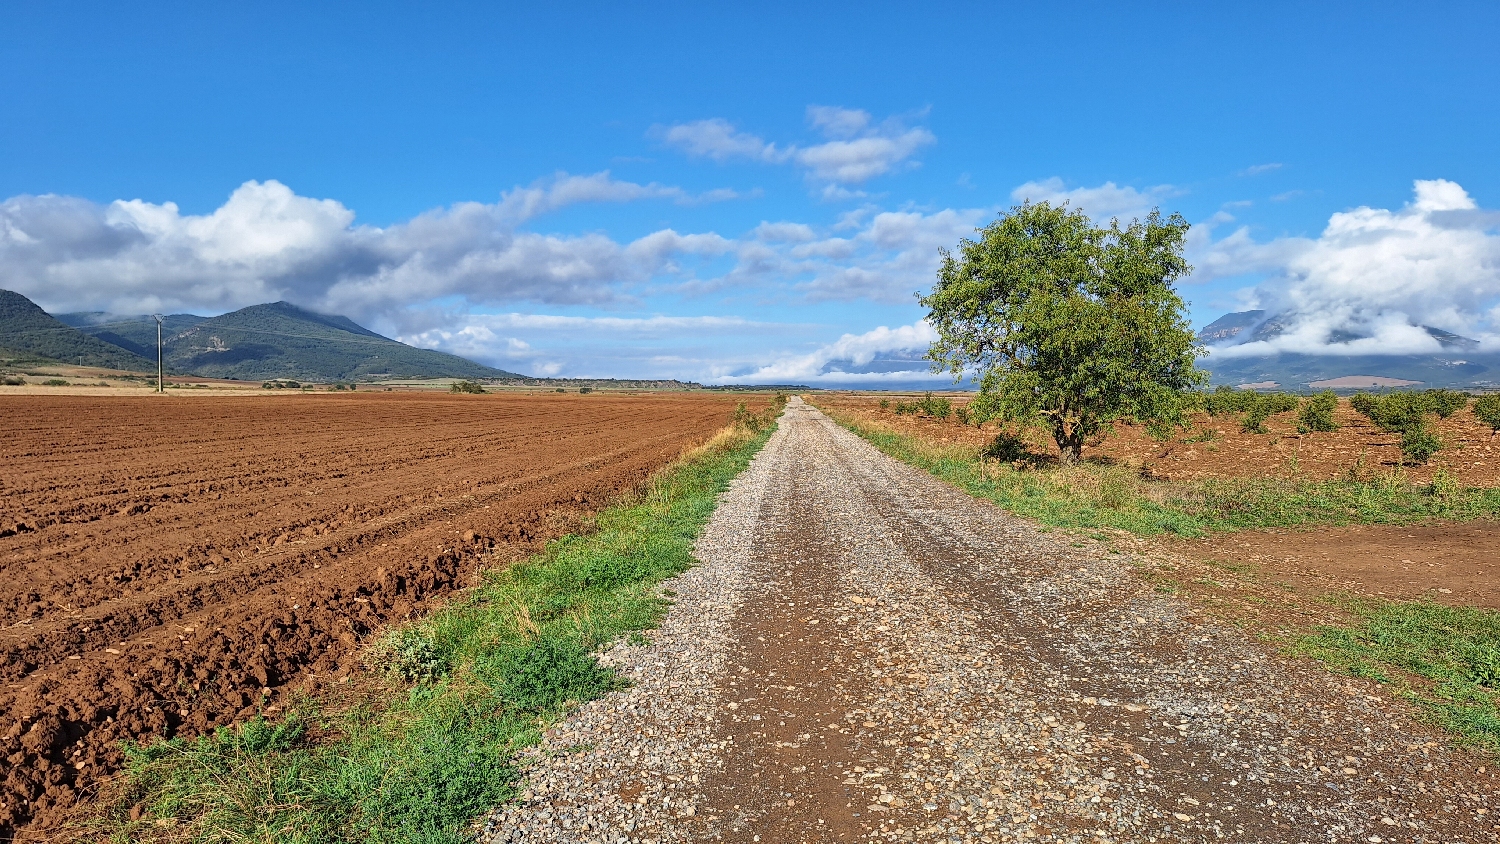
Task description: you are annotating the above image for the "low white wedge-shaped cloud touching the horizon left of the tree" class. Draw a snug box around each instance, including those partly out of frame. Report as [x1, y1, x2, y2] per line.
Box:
[719, 322, 942, 385]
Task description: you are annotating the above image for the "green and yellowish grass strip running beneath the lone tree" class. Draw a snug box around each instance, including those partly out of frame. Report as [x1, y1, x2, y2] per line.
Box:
[833, 411, 1500, 537]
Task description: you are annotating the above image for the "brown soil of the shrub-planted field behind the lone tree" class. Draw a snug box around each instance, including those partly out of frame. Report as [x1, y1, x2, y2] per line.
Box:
[818, 394, 1500, 487]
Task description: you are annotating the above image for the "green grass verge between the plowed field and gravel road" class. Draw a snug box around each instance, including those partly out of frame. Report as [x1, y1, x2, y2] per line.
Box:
[86, 425, 779, 844]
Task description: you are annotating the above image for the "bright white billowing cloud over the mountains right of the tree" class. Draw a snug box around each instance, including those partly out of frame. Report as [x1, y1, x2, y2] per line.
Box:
[1194, 178, 1500, 357]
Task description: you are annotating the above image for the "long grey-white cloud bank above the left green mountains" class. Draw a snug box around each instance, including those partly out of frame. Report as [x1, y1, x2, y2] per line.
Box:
[0, 172, 731, 318]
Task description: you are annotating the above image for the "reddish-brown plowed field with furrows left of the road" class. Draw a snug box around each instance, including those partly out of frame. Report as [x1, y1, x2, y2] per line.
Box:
[0, 393, 734, 840]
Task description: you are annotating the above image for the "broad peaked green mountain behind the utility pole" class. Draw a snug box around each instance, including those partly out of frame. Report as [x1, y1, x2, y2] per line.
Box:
[152, 301, 521, 381]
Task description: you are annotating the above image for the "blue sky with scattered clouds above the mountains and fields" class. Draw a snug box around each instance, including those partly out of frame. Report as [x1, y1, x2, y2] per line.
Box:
[0, 3, 1500, 387]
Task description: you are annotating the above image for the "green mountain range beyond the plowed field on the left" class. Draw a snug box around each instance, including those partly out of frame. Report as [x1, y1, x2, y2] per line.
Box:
[0, 291, 522, 381]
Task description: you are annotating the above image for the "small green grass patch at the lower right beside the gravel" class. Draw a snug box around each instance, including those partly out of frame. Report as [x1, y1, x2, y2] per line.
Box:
[1292, 600, 1500, 753]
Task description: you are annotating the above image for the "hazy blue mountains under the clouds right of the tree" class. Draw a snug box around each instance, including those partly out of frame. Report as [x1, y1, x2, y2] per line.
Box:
[1199, 310, 1500, 390]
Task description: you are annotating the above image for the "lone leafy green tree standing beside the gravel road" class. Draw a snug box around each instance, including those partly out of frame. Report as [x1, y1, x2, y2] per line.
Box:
[921, 202, 1205, 462]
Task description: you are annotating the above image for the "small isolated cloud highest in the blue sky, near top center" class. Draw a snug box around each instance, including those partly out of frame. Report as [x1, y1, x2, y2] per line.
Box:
[657, 105, 938, 193]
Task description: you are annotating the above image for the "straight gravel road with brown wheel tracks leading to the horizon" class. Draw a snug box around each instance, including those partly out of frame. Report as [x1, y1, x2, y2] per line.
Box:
[479, 399, 1500, 844]
